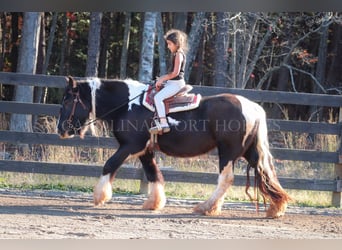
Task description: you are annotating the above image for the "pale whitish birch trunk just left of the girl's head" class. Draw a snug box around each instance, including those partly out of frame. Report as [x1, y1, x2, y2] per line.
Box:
[138, 12, 158, 82]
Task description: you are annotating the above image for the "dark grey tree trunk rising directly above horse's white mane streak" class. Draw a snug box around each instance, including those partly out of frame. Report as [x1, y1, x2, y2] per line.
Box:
[85, 12, 102, 76]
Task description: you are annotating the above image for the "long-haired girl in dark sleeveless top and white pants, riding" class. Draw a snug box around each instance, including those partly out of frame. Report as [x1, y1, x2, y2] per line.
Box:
[150, 29, 187, 134]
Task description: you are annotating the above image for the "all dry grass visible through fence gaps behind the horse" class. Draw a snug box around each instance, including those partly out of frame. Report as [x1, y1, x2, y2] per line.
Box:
[0, 114, 337, 207]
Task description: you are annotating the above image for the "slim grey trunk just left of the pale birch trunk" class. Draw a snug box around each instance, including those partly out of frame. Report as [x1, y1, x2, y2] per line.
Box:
[120, 12, 132, 79]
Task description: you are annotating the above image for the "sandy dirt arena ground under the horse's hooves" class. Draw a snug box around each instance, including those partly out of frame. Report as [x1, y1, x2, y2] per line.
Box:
[0, 189, 342, 239]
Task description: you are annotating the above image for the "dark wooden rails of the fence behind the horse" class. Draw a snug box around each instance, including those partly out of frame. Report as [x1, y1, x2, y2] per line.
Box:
[0, 72, 342, 207]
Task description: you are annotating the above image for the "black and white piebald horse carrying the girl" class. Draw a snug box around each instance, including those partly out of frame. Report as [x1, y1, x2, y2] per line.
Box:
[57, 77, 291, 218]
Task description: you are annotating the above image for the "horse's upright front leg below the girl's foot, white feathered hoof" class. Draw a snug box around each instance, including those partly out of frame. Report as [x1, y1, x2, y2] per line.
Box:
[139, 150, 166, 210]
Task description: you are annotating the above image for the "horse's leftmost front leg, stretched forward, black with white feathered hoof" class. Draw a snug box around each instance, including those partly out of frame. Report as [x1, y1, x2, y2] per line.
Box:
[94, 147, 129, 206]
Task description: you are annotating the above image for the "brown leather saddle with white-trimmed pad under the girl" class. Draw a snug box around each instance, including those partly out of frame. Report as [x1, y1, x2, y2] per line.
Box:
[143, 84, 202, 114]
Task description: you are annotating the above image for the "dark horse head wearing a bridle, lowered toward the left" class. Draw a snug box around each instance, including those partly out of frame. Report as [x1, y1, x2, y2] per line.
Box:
[57, 76, 92, 138]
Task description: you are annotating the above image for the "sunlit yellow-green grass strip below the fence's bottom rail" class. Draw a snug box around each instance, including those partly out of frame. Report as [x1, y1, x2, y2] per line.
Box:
[0, 172, 331, 207]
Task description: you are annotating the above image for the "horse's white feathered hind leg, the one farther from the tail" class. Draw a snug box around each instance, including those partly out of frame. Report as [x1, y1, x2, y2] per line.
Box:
[193, 161, 234, 216]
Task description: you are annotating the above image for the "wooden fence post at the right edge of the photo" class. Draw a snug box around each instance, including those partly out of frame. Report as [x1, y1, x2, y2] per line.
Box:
[331, 107, 342, 207]
